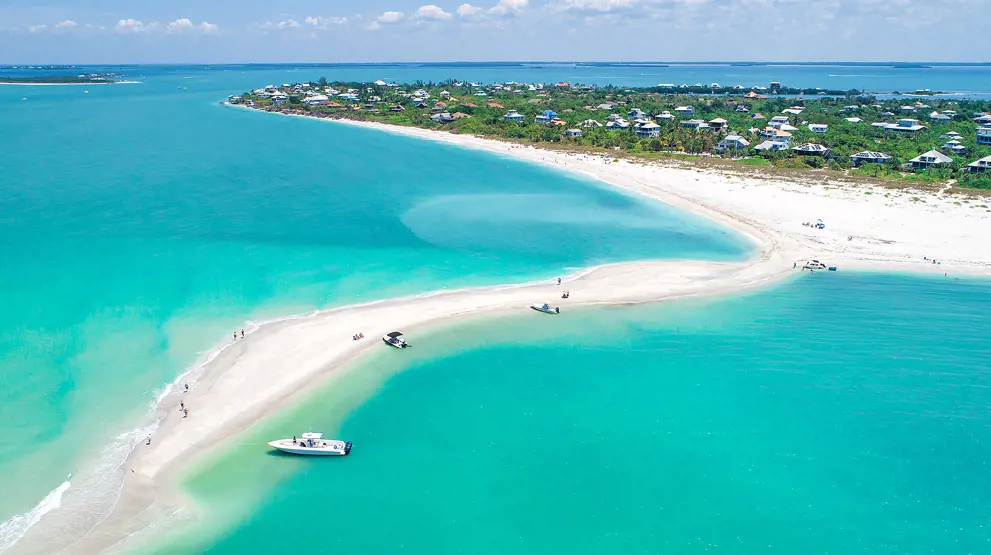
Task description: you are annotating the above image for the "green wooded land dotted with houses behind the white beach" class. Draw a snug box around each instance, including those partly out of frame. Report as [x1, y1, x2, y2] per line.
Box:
[228, 78, 991, 191]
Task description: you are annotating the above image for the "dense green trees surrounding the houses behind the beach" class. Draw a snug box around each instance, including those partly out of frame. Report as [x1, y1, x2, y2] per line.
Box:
[245, 79, 991, 189]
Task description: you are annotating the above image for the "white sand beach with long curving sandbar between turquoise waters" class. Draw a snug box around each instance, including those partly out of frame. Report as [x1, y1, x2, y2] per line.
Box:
[12, 114, 991, 554]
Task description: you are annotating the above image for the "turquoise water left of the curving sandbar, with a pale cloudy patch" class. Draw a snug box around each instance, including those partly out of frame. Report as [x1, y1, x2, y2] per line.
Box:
[0, 67, 751, 550]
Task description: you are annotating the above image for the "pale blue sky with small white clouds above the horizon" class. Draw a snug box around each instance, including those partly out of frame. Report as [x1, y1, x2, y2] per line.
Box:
[0, 0, 991, 64]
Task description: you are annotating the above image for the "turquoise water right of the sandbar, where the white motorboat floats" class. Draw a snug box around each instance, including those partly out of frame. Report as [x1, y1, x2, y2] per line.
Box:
[148, 273, 991, 555]
